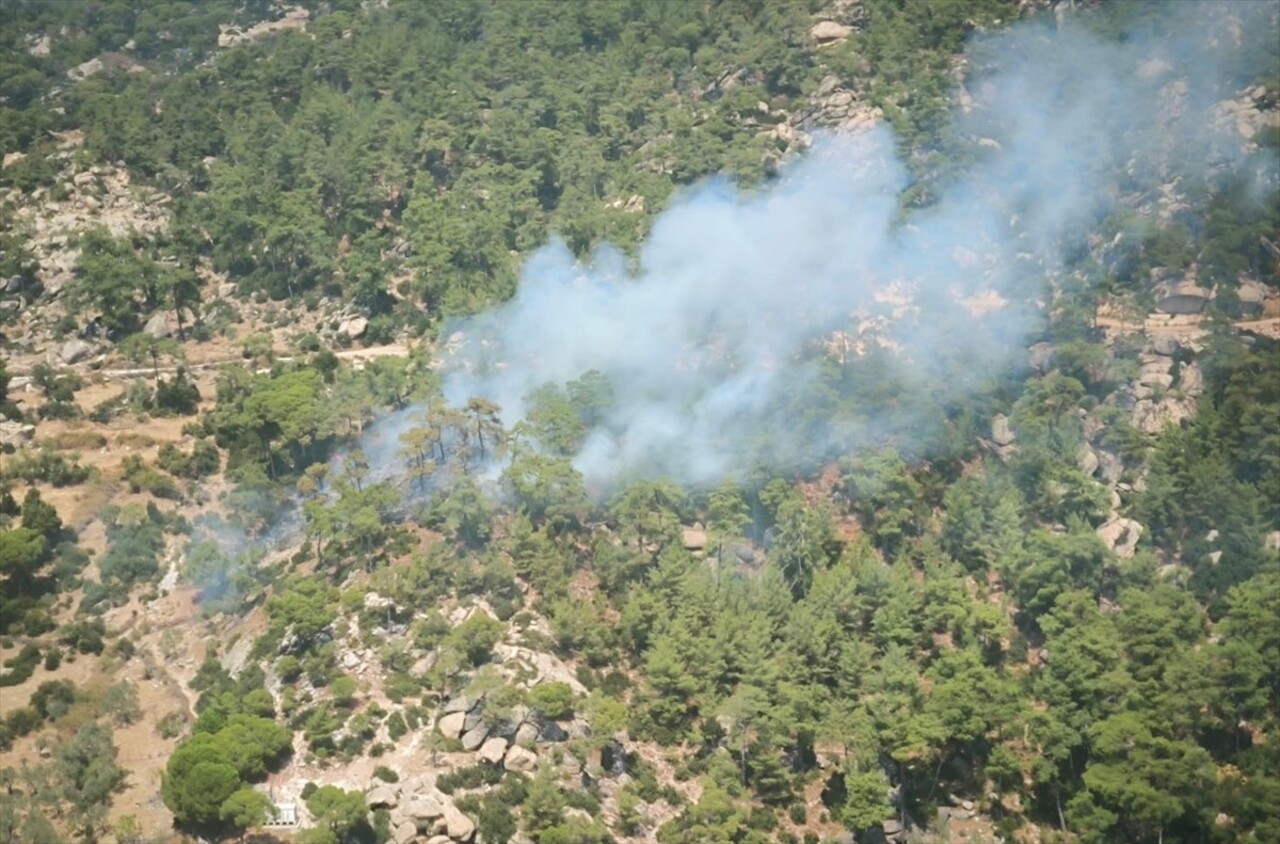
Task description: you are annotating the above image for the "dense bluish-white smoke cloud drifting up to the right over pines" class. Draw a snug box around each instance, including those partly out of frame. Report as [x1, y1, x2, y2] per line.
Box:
[427, 3, 1277, 487]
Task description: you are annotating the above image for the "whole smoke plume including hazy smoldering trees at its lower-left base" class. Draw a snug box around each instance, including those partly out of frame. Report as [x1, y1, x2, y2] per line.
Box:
[186, 3, 1277, 592]
